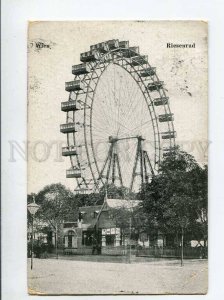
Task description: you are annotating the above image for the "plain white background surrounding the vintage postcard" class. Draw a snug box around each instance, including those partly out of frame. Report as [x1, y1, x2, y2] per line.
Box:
[1, 0, 224, 300]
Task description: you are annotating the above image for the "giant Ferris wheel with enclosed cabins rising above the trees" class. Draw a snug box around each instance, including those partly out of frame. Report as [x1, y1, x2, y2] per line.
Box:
[60, 39, 176, 193]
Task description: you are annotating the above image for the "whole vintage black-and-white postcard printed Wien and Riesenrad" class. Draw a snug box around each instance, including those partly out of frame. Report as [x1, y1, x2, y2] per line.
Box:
[27, 21, 209, 295]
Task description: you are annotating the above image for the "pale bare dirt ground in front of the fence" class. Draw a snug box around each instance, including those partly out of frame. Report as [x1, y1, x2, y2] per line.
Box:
[27, 257, 208, 295]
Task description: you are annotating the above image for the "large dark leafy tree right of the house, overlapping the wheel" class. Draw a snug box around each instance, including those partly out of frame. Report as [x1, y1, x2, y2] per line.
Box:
[142, 148, 207, 264]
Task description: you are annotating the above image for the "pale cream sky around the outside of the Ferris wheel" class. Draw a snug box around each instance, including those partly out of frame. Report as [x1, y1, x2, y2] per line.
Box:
[27, 21, 208, 193]
